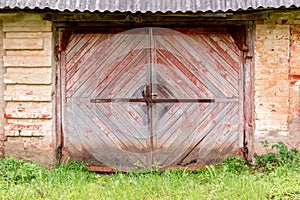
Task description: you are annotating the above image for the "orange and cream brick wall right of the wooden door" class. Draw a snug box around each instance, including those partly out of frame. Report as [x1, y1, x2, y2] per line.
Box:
[254, 14, 300, 153]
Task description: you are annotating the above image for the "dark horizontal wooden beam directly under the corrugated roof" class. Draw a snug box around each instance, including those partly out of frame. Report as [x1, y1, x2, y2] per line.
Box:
[44, 9, 300, 24]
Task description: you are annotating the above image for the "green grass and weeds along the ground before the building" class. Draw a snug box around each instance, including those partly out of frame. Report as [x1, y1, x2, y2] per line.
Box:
[0, 158, 300, 200]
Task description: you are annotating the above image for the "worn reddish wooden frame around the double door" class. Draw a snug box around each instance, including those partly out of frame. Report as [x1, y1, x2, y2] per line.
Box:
[55, 21, 254, 171]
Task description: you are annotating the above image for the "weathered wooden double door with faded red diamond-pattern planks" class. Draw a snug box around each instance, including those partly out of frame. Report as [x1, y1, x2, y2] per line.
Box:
[63, 28, 243, 168]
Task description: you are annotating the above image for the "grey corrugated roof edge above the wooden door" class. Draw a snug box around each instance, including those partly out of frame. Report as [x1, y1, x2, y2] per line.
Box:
[0, 0, 300, 13]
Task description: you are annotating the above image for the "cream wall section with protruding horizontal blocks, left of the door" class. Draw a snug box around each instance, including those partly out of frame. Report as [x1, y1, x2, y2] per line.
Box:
[3, 14, 55, 166]
